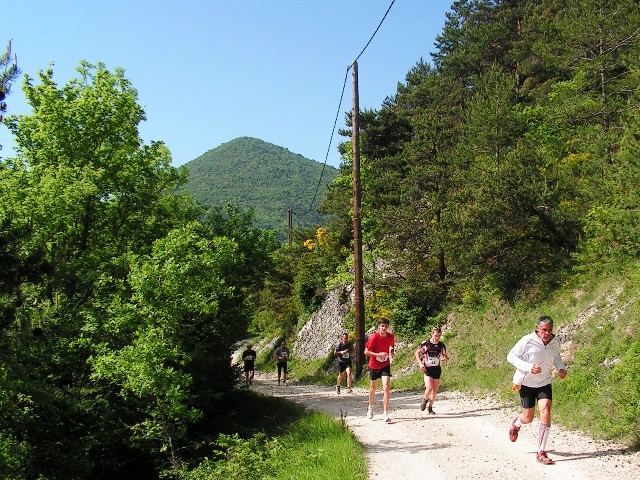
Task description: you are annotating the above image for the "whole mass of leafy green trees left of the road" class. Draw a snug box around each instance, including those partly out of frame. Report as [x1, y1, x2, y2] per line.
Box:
[0, 62, 277, 479]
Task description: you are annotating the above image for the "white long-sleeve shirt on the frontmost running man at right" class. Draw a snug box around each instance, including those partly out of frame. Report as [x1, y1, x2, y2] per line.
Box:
[507, 332, 565, 388]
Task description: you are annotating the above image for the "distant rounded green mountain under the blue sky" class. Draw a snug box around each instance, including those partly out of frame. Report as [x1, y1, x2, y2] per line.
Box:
[185, 137, 338, 238]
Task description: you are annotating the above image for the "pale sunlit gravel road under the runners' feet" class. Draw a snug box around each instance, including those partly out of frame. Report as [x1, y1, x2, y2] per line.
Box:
[252, 374, 640, 480]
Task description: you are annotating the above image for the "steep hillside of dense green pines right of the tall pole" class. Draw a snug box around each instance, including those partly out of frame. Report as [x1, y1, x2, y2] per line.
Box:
[325, 0, 640, 317]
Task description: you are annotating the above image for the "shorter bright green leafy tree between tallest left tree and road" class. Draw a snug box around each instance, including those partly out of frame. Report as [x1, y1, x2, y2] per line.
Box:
[91, 222, 241, 466]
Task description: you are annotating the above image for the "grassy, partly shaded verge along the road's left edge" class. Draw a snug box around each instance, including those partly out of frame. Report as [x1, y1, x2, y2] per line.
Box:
[172, 390, 367, 480]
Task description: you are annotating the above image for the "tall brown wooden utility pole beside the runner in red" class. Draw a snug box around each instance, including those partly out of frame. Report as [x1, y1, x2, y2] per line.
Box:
[351, 61, 365, 378]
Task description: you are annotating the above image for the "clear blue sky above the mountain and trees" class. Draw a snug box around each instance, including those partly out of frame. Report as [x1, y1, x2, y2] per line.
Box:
[0, 0, 452, 167]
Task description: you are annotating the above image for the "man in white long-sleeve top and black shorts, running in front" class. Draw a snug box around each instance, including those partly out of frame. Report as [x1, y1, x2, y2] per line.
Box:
[507, 316, 567, 465]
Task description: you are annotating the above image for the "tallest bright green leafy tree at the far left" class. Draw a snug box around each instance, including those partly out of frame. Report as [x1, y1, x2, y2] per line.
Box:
[0, 62, 198, 478]
